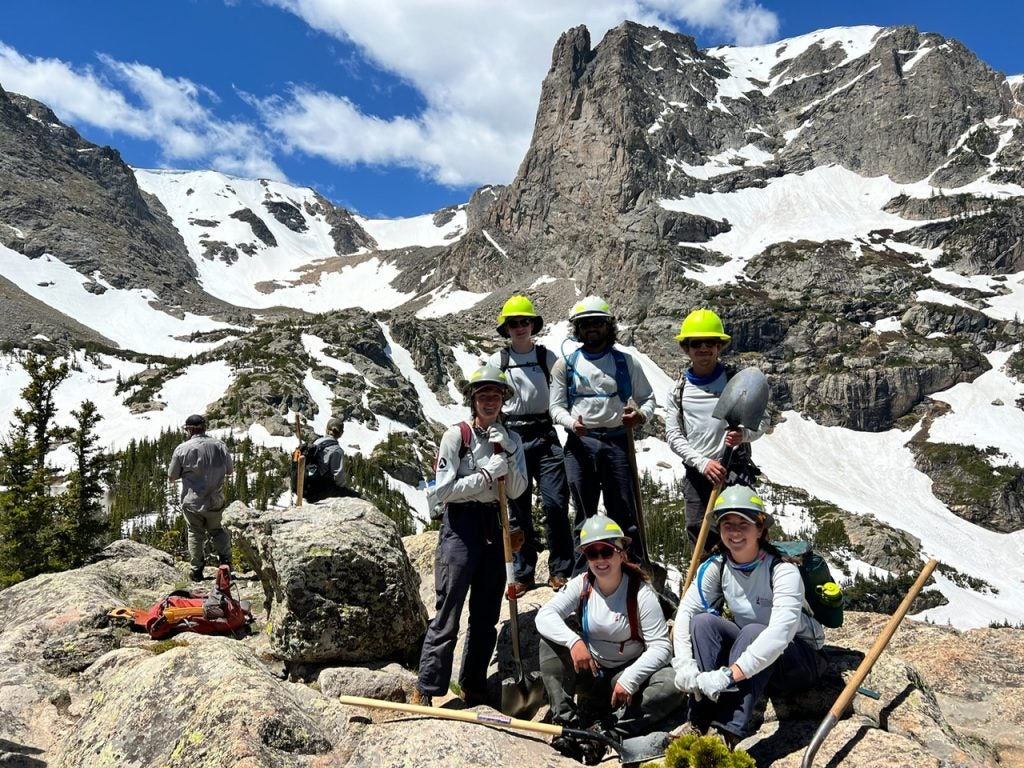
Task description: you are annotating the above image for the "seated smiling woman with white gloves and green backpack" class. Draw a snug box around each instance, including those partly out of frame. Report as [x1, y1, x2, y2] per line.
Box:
[672, 485, 825, 746]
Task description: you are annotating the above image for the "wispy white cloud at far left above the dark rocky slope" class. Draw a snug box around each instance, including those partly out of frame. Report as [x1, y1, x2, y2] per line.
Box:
[0, 43, 285, 179]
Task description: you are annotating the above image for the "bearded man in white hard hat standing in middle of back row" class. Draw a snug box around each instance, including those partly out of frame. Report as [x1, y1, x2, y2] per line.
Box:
[550, 296, 654, 572]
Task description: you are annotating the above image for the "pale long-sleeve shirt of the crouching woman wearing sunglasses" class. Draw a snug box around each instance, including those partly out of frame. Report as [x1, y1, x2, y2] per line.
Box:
[537, 573, 672, 693]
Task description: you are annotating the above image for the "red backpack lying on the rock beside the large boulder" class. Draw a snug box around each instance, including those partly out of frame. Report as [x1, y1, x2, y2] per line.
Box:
[126, 565, 253, 640]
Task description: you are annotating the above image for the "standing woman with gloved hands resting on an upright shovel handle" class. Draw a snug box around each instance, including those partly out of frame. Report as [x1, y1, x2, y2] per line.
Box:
[413, 365, 526, 707]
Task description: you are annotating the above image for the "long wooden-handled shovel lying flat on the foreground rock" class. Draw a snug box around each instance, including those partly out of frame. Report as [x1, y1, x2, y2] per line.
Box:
[338, 696, 670, 763]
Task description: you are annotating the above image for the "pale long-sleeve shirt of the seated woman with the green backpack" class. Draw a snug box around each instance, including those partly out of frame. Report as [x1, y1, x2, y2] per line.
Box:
[672, 553, 825, 677]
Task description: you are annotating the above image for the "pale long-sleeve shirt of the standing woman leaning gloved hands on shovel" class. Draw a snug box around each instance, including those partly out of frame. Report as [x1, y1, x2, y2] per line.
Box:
[434, 424, 526, 504]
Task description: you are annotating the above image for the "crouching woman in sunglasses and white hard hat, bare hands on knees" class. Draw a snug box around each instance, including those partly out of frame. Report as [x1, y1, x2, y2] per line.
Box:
[537, 515, 685, 765]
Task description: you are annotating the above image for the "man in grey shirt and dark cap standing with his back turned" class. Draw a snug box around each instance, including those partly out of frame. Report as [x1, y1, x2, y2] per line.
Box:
[167, 414, 234, 582]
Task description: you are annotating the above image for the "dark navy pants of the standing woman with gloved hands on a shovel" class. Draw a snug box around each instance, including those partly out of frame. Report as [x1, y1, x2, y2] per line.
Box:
[417, 502, 505, 696]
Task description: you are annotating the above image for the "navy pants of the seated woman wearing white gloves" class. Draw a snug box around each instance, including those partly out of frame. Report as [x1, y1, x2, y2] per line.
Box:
[690, 613, 826, 738]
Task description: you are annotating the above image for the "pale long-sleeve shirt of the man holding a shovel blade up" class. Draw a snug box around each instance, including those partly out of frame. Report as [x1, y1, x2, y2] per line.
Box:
[665, 368, 765, 472]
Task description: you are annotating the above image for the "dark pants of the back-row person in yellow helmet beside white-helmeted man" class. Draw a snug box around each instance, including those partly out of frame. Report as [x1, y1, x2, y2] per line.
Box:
[509, 426, 574, 584]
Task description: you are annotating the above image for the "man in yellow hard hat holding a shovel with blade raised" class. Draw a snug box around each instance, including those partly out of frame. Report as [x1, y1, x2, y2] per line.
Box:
[665, 309, 764, 552]
